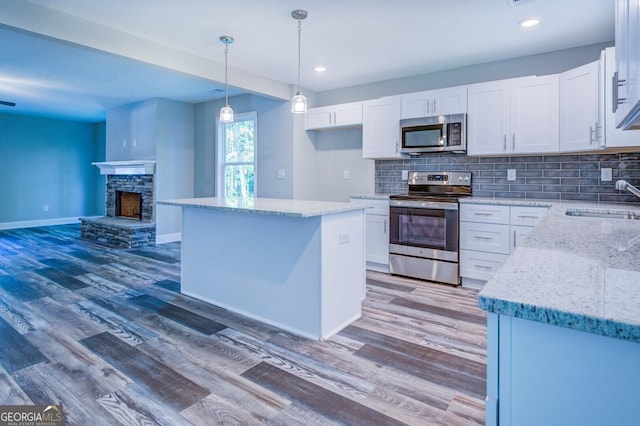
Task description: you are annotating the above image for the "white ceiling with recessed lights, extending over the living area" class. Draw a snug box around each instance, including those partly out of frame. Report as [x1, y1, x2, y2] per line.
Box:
[0, 0, 614, 121]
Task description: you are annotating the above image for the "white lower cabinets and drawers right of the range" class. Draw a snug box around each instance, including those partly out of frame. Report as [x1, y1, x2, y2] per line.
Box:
[460, 203, 547, 288]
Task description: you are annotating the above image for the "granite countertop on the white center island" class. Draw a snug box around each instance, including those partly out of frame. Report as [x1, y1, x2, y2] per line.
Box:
[156, 197, 366, 218]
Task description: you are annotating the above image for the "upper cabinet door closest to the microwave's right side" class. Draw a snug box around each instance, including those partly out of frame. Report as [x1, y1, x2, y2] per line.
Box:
[467, 80, 510, 155]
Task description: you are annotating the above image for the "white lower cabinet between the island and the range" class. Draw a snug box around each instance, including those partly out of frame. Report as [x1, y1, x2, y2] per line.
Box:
[351, 198, 389, 272]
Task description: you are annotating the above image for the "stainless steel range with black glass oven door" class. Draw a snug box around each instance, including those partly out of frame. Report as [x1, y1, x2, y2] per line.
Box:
[389, 172, 471, 285]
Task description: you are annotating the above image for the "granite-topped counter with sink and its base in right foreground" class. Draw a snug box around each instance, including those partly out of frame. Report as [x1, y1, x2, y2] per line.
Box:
[465, 200, 640, 425]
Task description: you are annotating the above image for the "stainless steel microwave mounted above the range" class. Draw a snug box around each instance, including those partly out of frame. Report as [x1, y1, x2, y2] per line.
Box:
[400, 114, 467, 155]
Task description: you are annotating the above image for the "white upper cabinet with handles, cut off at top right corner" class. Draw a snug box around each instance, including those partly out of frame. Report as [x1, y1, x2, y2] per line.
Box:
[613, 0, 640, 129]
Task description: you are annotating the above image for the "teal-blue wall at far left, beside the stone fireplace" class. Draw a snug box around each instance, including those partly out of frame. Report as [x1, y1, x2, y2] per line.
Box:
[0, 113, 104, 224]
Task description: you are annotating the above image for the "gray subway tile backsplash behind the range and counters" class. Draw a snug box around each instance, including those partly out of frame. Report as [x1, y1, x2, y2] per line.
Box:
[375, 152, 640, 203]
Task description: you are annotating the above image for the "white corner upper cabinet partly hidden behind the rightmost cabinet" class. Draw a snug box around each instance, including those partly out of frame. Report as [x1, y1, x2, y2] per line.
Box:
[600, 47, 640, 148]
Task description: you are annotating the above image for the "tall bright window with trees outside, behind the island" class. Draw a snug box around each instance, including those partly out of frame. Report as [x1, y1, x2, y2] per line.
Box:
[217, 112, 257, 199]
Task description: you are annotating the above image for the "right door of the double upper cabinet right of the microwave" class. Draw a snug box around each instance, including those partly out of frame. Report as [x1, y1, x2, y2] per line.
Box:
[507, 74, 559, 154]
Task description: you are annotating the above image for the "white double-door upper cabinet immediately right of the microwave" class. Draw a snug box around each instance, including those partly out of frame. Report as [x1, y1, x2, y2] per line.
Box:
[467, 74, 559, 155]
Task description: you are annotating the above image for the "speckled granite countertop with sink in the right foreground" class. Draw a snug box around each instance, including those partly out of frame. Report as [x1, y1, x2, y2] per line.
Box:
[478, 199, 640, 343]
